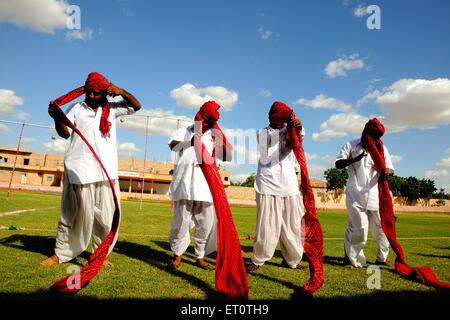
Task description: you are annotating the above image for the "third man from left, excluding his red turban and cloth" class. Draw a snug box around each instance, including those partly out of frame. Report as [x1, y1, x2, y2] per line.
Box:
[247, 119, 305, 271]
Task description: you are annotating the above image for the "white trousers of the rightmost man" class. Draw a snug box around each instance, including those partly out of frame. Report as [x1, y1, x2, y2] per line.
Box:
[344, 201, 389, 267]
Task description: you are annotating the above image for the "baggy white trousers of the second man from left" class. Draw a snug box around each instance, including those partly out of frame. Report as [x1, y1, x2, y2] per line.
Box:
[169, 200, 217, 259]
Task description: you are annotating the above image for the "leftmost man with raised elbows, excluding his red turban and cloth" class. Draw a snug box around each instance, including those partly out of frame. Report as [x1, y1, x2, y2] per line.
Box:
[41, 74, 141, 266]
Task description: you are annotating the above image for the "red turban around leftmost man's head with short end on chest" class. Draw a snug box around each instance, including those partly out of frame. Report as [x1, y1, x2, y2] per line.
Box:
[53, 72, 112, 136]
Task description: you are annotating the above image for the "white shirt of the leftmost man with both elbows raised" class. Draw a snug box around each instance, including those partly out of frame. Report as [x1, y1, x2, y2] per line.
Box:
[64, 99, 135, 184]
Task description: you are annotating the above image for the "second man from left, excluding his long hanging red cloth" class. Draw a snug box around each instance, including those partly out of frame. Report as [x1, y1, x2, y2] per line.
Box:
[168, 101, 231, 270]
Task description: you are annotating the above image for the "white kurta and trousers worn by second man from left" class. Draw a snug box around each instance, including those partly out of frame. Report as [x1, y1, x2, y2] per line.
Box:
[168, 125, 217, 259]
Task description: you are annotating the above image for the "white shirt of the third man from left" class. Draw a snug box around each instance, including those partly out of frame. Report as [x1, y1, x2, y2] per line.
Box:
[254, 126, 305, 197]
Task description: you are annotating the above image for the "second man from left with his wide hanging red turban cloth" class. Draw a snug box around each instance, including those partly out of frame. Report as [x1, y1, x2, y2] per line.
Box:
[168, 101, 248, 299]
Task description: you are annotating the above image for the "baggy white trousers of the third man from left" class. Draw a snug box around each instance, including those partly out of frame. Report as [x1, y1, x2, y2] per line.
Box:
[252, 193, 304, 268]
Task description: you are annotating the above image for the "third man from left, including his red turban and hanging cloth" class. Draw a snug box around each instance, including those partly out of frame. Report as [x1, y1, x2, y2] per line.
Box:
[247, 101, 323, 294]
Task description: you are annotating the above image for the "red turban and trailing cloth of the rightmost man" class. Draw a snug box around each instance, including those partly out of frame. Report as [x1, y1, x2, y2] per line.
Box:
[361, 118, 450, 288]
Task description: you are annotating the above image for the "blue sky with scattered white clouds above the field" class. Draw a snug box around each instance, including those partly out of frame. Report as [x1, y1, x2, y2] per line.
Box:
[0, 0, 450, 192]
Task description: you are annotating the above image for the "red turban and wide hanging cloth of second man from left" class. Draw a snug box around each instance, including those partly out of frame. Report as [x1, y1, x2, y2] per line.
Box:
[194, 101, 248, 299]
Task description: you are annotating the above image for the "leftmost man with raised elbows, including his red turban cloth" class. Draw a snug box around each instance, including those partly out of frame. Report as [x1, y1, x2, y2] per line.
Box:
[40, 72, 141, 291]
